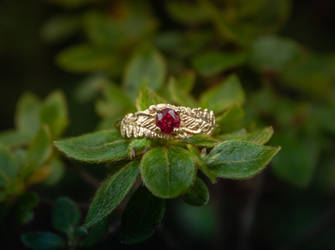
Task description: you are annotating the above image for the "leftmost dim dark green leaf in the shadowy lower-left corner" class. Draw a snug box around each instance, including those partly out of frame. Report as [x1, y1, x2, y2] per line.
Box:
[16, 192, 40, 224]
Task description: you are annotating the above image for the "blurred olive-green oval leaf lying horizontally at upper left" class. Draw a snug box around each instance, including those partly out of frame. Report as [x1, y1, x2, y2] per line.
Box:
[56, 44, 116, 73]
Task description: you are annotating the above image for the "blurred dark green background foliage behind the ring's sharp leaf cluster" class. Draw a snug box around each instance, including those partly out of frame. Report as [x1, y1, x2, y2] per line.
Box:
[0, 0, 335, 249]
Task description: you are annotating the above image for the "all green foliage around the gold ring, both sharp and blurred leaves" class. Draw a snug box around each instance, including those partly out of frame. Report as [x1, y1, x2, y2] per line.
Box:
[0, 0, 335, 249]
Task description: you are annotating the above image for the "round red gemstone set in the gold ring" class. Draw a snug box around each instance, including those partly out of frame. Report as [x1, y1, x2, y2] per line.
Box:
[156, 108, 180, 134]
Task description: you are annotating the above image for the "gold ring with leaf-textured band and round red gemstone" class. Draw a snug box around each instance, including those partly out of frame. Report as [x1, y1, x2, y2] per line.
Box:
[120, 104, 215, 139]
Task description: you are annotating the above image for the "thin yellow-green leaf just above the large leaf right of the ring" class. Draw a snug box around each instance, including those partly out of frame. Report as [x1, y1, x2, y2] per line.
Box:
[217, 127, 273, 145]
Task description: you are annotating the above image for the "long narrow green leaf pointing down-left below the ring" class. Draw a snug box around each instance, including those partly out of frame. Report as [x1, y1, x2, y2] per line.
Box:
[84, 161, 139, 227]
